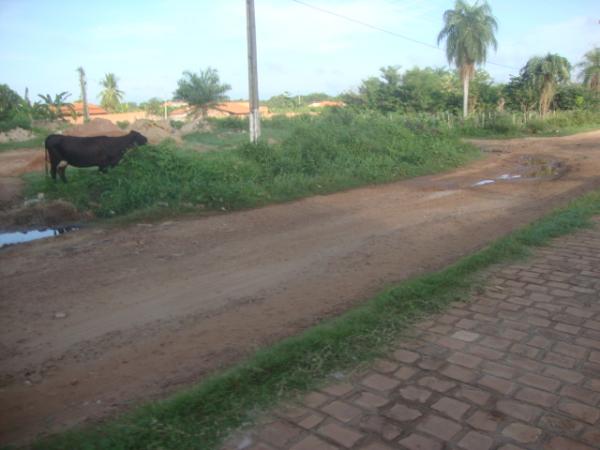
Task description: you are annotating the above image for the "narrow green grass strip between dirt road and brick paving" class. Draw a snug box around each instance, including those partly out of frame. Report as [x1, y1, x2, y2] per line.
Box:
[29, 191, 600, 450]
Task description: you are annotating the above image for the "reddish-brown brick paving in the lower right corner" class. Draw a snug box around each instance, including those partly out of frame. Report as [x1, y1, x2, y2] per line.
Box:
[224, 223, 600, 450]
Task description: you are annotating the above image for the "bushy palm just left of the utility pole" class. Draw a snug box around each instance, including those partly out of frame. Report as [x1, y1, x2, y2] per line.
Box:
[173, 67, 231, 117]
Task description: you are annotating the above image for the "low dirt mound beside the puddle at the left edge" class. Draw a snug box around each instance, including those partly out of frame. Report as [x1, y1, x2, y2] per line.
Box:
[0, 198, 90, 229]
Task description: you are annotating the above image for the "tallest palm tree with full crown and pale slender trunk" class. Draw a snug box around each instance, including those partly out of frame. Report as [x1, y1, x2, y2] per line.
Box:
[438, 0, 498, 117]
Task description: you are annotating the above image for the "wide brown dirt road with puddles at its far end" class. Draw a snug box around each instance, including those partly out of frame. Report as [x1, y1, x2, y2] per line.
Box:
[0, 132, 600, 443]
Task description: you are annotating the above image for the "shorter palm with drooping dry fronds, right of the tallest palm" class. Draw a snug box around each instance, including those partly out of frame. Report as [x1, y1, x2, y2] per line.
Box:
[521, 53, 571, 116]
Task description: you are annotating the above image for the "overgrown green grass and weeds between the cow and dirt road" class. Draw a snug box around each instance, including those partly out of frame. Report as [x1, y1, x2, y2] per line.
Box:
[27, 110, 480, 218]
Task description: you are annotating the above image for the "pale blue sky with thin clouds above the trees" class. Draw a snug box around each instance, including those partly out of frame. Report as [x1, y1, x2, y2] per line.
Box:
[0, 0, 600, 103]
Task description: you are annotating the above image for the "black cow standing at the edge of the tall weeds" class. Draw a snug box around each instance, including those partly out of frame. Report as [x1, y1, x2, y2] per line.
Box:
[45, 131, 148, 183]
